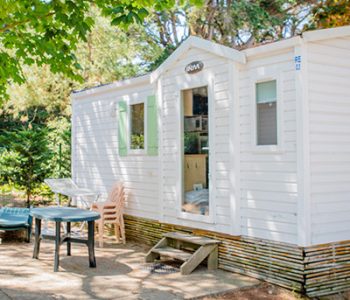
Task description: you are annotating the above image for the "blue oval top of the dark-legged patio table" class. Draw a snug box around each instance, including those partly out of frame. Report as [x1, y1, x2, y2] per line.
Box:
[30, 206, 100, 222]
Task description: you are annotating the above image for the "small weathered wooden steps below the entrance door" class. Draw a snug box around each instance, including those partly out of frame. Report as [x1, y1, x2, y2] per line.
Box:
[145, 232, 221, 275]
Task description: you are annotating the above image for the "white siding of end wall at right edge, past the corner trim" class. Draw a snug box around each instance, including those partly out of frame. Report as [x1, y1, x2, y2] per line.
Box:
[308, 37, 350, 244]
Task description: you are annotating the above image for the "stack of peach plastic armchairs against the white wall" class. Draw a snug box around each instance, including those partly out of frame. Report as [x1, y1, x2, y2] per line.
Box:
[92, 182, 125, 247]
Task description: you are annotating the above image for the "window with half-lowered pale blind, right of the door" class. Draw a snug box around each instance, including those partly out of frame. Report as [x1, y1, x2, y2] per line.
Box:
[256, 80, 277, 146]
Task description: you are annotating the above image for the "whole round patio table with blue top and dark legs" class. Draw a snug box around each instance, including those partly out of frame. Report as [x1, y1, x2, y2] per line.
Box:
[30, 206, 100, 272]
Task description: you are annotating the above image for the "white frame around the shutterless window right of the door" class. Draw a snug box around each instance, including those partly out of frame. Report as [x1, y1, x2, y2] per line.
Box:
[250, 72, 283, 153]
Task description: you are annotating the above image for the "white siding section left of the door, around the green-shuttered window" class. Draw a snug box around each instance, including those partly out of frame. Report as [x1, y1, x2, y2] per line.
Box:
[73, 86, 159, 219]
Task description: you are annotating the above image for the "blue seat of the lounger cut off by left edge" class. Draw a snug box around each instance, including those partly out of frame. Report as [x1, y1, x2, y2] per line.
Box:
[0, 207, 30, 229]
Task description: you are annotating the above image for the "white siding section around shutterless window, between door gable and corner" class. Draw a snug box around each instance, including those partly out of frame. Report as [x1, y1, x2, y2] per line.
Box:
[239, 49, 298, 243]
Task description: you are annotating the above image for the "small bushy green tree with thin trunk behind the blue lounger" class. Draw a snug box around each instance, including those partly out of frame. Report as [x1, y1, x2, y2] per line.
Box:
[0, 127, 52, 206]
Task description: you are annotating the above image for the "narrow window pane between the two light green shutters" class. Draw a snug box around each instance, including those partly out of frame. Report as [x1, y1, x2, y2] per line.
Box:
[130, 103, 145, 150]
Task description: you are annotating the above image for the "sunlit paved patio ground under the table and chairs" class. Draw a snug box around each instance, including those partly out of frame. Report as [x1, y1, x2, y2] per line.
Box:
[0, 236, 259, 300]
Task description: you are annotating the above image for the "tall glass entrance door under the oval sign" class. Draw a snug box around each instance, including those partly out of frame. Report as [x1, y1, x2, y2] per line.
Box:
[182, 86, 209, 216]
